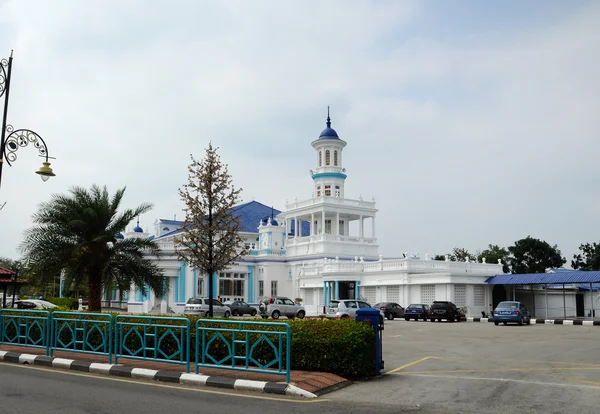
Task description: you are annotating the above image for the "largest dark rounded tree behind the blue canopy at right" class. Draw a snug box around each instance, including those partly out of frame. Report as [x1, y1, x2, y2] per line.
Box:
[508, 236, 567, 273]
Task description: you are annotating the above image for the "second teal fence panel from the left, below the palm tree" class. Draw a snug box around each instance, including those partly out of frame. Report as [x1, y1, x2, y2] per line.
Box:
[50, 312, 113, 364]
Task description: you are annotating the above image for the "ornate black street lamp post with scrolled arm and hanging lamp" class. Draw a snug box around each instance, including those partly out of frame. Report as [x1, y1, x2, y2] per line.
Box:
[0, 51, 55, 192]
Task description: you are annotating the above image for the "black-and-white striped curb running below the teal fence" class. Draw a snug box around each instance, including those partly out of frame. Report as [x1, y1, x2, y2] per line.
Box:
[0, 351, 317, 398]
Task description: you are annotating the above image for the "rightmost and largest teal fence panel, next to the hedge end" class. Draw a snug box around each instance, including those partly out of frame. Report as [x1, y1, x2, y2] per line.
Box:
[195, 319, 291, 382]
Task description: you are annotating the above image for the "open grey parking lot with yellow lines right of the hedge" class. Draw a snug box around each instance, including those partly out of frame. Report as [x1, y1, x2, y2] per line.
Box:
[328, 320, 600, 413]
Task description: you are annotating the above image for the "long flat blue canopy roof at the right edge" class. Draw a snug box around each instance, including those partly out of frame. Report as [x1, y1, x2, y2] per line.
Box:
[486, 270, 600, 289]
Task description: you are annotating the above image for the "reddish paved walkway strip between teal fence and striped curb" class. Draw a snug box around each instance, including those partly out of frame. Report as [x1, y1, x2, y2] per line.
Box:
[0, 344, 350, 395]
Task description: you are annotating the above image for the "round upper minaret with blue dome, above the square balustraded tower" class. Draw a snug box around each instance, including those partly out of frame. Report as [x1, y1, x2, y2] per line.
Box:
[311, 107, 346, 198]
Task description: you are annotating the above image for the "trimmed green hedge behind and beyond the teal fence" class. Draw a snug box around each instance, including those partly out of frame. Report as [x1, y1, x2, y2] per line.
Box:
[3, 312, 375, 378]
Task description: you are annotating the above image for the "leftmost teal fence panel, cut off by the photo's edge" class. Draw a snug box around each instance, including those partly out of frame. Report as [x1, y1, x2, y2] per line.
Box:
[0, 309, 52, 354]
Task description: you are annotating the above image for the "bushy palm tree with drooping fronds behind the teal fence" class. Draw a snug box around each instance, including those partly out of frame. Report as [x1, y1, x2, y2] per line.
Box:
[20, 185, 166, 311]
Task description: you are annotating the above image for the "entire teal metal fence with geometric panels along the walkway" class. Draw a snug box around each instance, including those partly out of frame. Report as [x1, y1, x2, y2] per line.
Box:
[0, 309, 291, 382]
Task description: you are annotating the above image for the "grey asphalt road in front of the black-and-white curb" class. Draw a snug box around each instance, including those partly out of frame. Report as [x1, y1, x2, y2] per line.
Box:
[0, 363, 399, 414]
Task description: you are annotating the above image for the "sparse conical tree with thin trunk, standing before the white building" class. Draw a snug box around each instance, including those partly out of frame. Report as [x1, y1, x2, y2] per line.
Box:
[176, 143, 245, 316]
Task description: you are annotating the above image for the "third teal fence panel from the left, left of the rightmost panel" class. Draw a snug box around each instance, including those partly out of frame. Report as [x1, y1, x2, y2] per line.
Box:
[114, 315, 191, 372]
